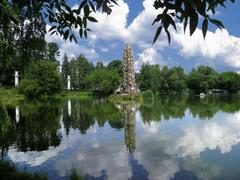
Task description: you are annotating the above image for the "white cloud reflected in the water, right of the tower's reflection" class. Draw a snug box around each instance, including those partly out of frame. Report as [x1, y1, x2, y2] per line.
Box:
[140, 109, 240, 157]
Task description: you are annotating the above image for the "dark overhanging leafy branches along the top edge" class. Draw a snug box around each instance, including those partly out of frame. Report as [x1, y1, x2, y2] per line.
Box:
[0, 0, 235, 42]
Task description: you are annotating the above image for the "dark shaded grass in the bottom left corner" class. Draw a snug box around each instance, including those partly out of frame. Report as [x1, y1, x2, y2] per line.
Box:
[0, 160, 47, 180]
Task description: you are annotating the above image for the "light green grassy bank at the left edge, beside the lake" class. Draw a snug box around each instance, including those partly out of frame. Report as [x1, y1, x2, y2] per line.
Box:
[0, 87, 24, 105]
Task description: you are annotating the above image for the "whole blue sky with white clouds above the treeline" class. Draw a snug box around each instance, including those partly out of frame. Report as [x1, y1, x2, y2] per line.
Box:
[46, 0, 240, 72]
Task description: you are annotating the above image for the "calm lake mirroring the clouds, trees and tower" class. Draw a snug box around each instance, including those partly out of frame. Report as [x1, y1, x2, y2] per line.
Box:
[1, 95, 240, 180]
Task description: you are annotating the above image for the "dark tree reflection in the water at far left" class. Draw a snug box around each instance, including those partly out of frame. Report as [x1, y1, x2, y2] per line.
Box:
[1, 102, 61, 152]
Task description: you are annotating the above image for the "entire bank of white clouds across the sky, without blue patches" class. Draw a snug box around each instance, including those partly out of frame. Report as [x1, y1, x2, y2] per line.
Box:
[46, 0, 240, 70]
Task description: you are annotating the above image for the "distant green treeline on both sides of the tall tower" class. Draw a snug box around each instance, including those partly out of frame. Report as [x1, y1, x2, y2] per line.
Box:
[62, 55, 240, 93]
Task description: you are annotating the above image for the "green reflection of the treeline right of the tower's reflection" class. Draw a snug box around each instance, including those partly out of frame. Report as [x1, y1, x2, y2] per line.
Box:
[140, 95, 240, 122]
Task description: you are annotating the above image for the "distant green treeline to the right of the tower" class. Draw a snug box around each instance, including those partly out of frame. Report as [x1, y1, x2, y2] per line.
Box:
[137, 64, 240, 93]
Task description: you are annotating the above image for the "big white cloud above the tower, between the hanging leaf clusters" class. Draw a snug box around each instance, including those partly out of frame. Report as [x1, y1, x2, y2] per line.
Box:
[46, 0, 167, 68]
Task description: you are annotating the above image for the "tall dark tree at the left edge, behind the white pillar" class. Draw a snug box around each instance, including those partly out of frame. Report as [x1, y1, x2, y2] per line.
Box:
[0, 0, 46, 85]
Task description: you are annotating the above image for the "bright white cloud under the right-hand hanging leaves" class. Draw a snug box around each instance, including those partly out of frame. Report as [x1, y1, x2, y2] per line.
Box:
[172, 25, 240, 68]
